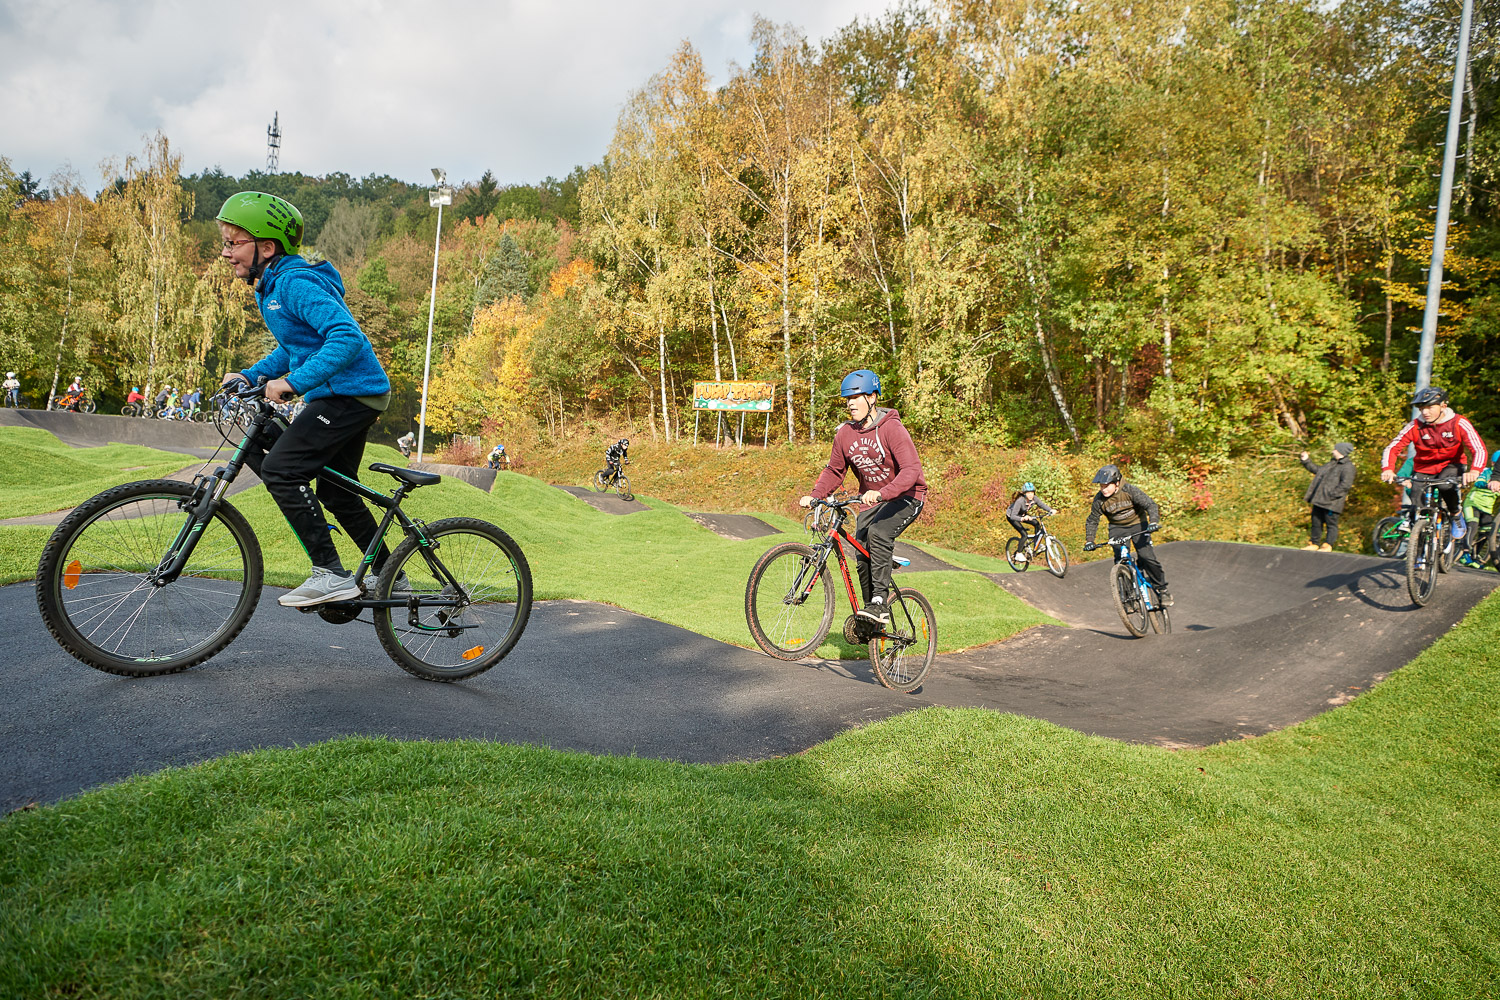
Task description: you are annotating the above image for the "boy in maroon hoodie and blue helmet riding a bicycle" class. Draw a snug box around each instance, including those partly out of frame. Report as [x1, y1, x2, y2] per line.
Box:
[800, 369, 927, 625]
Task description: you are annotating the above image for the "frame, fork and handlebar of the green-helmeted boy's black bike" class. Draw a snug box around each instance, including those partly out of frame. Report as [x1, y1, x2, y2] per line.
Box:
[153, 390, 477, 631]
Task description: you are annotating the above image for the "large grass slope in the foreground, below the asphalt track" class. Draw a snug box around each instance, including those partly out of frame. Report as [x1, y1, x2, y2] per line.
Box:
[0, 597, 1500, 1000]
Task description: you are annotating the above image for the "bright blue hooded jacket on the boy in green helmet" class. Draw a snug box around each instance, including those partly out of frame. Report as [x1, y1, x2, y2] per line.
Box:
[245, 255, 390, 399]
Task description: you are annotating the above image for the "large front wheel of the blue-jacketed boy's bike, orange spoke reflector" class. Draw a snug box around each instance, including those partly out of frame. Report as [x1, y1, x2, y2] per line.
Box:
[36, 480, 261, 678]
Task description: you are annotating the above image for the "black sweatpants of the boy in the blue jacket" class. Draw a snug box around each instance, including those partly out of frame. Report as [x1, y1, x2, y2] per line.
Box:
[245, 396, 390, 573]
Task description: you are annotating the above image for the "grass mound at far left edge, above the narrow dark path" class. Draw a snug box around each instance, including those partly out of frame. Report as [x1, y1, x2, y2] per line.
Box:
[0, 427, 194, 517]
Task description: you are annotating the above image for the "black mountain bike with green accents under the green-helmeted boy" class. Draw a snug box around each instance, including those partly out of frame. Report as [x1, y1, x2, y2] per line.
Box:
[36, 385, 531, 681]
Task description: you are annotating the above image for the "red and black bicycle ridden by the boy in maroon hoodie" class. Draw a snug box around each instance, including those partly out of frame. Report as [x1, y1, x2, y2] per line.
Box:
[746, 496, 938, 693]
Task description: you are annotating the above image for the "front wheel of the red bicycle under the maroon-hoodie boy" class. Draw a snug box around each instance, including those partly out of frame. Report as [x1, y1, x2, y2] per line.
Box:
[746, 541, 834, 660]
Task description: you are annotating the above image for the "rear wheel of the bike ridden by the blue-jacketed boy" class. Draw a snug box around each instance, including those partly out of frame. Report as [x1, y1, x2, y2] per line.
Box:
[375, 517, 531, 681]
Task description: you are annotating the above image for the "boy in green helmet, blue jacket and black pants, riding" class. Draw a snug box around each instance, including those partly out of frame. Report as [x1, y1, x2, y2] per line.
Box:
[218, 190, 390, 607]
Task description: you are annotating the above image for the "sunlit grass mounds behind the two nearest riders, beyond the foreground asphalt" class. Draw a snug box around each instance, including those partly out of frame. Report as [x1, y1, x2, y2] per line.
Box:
[0, 431, 1052, 658]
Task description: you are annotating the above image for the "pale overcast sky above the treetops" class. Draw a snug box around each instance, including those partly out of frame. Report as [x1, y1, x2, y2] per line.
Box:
[0, 0, 890, 187]
